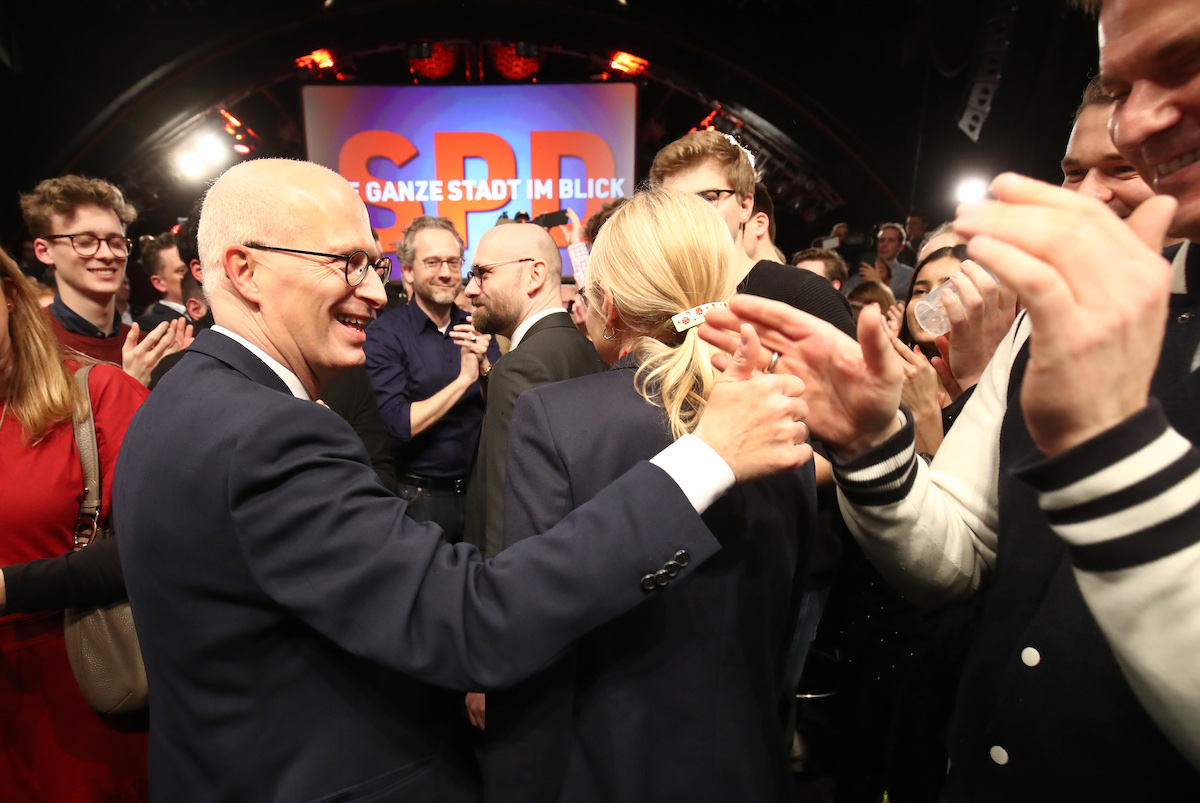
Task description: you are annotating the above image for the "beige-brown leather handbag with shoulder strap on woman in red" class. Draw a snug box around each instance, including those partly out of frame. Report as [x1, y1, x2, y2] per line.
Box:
[64, 366, 150, 714]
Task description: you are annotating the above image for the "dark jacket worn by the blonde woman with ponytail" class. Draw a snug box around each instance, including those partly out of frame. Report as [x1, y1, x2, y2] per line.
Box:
[484, 358, 816, 803]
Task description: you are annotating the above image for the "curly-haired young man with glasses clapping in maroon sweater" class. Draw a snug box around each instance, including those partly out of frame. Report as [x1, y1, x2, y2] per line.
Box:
[20, 175, 191, 384]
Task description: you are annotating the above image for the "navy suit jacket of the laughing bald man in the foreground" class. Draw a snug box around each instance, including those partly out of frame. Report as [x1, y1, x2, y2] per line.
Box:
[113, 331, 719, 803]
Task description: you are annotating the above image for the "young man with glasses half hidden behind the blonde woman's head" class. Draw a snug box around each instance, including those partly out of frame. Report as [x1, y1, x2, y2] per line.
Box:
[650, 131, 854, 336]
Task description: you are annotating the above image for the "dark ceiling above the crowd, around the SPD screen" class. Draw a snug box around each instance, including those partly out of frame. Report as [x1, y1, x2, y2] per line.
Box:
[0, 0, 1097, 251]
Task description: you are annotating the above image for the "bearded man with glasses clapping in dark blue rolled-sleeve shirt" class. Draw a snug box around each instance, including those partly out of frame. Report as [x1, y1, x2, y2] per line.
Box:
[365, 215, 500, 541]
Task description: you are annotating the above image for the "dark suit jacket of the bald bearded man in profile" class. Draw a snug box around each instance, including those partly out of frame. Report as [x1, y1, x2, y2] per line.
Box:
[463, 310, 604, 556]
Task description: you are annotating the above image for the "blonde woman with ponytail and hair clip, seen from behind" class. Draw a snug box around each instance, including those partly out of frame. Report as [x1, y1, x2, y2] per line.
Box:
[484, 188, 816, 803]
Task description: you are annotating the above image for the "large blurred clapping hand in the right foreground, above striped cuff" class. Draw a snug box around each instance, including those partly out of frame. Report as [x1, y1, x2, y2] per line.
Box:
[954, 173, 1176, 455]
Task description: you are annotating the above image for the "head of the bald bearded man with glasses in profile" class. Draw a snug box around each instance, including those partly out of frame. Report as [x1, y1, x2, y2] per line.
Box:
[467, 223, 534, 337]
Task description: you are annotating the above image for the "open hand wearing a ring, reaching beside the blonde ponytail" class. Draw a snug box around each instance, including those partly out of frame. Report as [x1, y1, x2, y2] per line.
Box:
[700, 295, 904, 459]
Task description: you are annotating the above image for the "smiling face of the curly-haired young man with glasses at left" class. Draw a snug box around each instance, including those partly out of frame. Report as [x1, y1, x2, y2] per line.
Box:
[34, 205, 128, 306]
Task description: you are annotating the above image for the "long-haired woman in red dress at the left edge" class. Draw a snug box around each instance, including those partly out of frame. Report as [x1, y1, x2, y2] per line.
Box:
[0, 251, 146, 803]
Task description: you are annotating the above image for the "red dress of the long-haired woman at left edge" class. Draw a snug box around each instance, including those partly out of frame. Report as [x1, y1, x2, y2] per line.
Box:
[0, 362, 148, 803]
